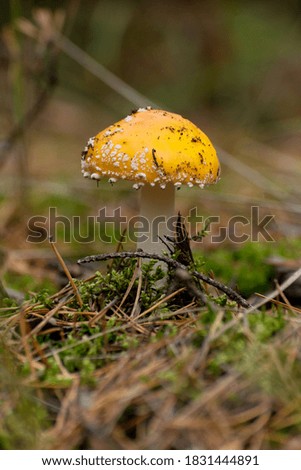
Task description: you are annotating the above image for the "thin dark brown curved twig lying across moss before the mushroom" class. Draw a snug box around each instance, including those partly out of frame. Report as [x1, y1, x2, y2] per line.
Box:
[77, 251, 251, 308]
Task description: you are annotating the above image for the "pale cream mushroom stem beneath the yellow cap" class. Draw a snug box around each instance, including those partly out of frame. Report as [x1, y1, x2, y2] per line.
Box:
[137, 184, 175, 254]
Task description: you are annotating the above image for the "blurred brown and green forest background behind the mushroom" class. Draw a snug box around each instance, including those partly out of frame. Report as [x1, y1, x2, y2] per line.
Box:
[0, 0, 301, 294]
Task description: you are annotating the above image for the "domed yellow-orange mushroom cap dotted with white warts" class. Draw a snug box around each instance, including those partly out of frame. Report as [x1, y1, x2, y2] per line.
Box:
[82, 107, 220, 188]
